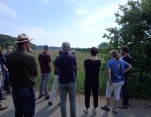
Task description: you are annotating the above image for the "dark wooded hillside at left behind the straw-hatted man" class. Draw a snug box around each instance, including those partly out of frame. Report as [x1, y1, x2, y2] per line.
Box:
[0, 34, 36, 49]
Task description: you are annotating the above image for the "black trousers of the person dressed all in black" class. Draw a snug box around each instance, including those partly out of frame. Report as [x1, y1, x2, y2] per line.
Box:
[84, 82, 99, 108]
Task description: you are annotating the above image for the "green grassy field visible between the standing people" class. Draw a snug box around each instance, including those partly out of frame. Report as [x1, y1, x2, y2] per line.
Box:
[33, 50, 106, 95]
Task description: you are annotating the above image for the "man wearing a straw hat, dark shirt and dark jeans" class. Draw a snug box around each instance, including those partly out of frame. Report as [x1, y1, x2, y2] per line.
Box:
[7, 34, 38, 117]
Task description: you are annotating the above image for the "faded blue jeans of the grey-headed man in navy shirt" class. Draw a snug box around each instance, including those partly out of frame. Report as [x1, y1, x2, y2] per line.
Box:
[60, 83, 76, 117]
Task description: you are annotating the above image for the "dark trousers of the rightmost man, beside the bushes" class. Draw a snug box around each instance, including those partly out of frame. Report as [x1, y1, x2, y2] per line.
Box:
[122, 78, 129, 105]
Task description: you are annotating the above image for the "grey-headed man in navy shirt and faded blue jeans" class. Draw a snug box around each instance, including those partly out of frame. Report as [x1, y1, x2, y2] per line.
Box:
[55, 42, 76, 117]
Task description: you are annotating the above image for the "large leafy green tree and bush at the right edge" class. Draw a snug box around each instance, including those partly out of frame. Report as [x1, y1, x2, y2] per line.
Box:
[103, 0, 151, 97]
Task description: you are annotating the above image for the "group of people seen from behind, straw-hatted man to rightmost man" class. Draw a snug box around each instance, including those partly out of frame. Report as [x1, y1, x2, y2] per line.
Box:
[0, 34, 132, 117]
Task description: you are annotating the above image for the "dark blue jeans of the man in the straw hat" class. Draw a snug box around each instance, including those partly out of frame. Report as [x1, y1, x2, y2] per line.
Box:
[12, 88, 35, 117]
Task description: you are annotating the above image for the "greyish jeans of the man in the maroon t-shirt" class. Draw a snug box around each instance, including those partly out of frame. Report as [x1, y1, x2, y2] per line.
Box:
[39, 73, 50, 96]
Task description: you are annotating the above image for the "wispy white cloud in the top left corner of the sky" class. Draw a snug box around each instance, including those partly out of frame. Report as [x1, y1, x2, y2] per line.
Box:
[0, 1, 18, 19]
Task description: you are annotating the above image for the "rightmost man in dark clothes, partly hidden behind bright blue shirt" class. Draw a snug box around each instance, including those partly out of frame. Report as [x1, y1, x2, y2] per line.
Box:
[119, 46, 132, 108]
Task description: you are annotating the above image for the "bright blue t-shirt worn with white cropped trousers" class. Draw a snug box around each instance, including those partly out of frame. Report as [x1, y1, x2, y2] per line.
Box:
[106, 59, 129, 83]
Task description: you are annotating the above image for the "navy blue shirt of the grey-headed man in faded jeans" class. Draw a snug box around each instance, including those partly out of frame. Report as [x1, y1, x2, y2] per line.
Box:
[55, 53, 77, 84]
